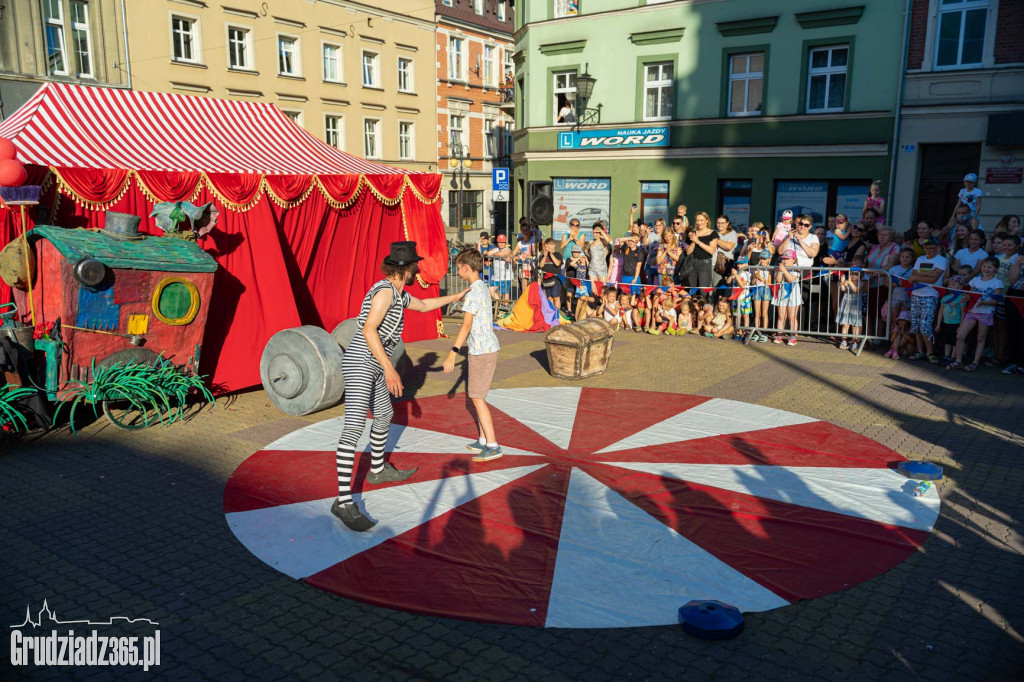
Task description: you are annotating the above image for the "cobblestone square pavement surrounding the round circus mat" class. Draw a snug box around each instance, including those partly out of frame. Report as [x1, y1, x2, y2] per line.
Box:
[0, 323, 1024, 682]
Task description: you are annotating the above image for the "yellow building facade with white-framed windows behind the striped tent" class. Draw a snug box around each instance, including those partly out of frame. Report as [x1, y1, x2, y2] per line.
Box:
[127, 0, 437, 171]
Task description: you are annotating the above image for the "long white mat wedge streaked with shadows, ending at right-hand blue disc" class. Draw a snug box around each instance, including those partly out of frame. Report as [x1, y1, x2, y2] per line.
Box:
[607, 462, 940, 530]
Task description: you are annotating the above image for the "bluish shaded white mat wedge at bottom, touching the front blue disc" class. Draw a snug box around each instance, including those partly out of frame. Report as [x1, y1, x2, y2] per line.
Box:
[545, 469, 788, 628]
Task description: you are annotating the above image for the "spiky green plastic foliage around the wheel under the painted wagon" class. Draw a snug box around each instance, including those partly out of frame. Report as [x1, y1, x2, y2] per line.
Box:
[53, 355, 216, 432]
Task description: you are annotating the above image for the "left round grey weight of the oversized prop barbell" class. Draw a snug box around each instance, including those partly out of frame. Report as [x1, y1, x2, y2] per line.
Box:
[259, 326, 345, 417]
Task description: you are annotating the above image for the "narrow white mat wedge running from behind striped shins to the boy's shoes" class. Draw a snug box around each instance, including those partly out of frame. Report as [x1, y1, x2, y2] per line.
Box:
[264, 417, 541, 457]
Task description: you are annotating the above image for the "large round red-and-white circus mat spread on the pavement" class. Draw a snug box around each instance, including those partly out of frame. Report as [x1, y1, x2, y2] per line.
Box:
[224, 387, 939, 628]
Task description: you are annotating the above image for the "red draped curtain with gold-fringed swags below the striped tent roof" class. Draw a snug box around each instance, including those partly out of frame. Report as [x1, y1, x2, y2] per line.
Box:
[0, 169, 446, 391]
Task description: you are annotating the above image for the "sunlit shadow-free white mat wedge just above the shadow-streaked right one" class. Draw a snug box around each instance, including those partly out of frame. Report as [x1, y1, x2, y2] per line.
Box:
[599, 398, 818, 454]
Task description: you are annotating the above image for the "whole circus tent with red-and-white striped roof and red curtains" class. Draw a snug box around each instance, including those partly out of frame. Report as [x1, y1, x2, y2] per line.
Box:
[0, 83, 447, 390]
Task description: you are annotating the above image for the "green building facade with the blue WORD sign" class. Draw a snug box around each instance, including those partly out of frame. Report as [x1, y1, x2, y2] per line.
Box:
[513, 0, 904, 235]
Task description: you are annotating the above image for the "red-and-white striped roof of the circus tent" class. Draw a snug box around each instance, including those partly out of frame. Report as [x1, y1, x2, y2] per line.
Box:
[0, 83, 407, 175]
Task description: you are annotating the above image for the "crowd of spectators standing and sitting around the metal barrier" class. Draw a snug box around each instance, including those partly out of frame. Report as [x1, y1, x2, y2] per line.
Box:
[468, 173, 1024, 374]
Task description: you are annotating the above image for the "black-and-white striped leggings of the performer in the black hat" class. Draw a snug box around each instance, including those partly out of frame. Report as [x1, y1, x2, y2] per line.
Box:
[336, 354, 394, 503]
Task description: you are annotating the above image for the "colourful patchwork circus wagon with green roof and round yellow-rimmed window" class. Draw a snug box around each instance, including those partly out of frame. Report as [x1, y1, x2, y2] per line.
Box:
[0, 213, 217, 428]
